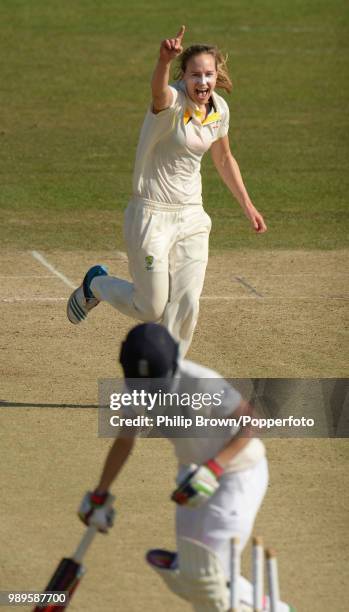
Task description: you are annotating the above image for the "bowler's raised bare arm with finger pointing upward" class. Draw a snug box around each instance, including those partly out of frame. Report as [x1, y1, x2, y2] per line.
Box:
[151, 26, 185, 113]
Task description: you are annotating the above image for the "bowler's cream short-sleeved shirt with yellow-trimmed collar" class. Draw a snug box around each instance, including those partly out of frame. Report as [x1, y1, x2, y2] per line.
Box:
[133, 81, 229, 205]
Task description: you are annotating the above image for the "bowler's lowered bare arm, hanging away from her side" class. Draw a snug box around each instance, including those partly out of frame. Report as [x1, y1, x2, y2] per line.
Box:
[211, 136, 267, 234]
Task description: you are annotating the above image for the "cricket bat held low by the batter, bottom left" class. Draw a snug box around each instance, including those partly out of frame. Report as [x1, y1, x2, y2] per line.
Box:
[33, 525, 97, 612]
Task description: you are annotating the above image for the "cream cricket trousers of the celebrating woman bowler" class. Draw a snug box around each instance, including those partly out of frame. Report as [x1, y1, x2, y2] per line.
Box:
[91, 197, 211, 357]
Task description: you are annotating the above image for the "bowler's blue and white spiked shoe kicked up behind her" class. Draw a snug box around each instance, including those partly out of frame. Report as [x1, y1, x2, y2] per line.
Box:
[67, 265, 108, 325]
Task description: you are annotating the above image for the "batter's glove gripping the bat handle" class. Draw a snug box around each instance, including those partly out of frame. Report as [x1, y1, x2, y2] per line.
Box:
[78, 491, 115, 533]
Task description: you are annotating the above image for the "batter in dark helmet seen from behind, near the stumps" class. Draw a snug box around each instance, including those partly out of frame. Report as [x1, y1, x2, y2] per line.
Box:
[79, 323, 290, 612]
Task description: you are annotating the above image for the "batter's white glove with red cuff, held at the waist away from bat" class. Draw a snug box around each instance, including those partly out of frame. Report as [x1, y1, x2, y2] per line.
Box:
[171, 459, 223, 508]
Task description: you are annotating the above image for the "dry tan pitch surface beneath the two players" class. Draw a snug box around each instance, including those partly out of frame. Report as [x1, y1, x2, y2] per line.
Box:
[0, 251, 349, 612]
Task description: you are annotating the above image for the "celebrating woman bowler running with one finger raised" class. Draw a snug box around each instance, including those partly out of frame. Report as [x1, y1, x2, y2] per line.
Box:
[67, 26, 266, 356]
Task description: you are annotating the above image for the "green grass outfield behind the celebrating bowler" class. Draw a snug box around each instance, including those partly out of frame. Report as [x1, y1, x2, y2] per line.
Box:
[0, 0, 349, 249]
